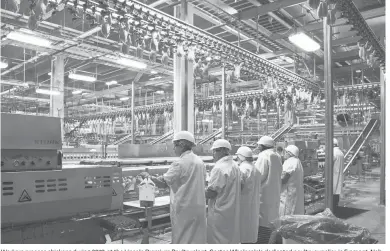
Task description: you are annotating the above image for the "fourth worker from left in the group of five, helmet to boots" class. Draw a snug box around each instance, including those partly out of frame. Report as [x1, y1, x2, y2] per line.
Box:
[255, 136, 283, 244]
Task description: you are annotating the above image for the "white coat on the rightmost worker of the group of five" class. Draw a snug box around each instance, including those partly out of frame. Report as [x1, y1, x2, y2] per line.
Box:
[279, 157, 305, 216]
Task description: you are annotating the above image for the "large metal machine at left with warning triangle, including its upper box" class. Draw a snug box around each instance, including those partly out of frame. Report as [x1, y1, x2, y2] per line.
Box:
[1, 113, 123, 243]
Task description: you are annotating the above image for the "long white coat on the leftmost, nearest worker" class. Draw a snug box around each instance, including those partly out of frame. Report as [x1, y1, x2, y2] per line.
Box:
[164, 151, 207, 244]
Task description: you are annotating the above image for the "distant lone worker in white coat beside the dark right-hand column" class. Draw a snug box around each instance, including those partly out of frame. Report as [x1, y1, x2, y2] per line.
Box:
[333, 139, 344, 211]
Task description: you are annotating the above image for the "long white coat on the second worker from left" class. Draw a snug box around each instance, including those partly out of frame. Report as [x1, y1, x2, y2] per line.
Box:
[207, 156, 241, 244]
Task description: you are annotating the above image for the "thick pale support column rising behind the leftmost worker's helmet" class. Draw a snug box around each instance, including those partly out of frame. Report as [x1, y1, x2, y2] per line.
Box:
[173, 0, 195, 133]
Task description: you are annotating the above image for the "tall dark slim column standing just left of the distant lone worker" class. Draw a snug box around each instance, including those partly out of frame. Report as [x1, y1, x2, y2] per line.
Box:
[323, 17, 334, 212]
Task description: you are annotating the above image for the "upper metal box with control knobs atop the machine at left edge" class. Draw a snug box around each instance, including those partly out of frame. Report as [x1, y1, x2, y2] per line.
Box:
[1, 113, 62, 172]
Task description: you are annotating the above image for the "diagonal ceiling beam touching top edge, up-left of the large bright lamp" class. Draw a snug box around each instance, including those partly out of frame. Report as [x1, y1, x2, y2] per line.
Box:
[238, 0, 305, 20]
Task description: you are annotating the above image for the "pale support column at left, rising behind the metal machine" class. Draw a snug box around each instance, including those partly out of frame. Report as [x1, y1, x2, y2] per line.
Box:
[50, 55, 65, 141]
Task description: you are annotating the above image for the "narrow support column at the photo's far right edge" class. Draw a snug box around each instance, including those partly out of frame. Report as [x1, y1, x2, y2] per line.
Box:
[379, 32, 386, 205]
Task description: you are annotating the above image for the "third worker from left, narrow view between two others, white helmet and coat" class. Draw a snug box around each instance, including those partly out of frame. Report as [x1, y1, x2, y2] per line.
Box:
[236, 146, 261, 244]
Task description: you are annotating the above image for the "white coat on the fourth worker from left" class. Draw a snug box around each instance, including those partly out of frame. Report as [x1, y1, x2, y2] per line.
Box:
[255, 149, 283, 227]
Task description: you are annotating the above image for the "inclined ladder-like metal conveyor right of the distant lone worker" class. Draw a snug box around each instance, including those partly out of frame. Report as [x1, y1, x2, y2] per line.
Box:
[343, 119, 378, 173]
